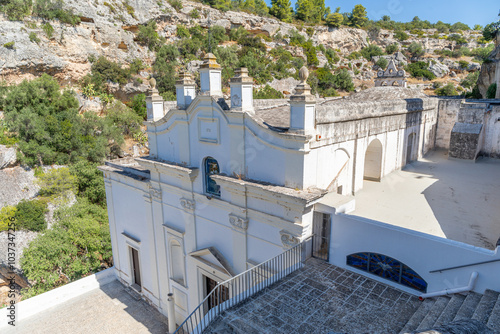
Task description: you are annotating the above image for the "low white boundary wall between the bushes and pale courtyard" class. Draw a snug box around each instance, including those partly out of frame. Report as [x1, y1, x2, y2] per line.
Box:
[0, 267, 116, 332]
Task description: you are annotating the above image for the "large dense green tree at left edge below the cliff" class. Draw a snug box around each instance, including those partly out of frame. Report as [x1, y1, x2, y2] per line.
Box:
[3, 74, 123, 166]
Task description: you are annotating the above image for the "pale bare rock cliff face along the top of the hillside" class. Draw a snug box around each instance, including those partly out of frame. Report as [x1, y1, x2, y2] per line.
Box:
[0, 0, 484, 88]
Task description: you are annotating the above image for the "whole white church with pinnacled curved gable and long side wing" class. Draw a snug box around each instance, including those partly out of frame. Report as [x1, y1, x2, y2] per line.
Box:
[96, 54, 458, 323]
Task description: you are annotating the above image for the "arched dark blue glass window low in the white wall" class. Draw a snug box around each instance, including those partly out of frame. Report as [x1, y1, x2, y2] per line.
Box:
[346, 252, 427, 292]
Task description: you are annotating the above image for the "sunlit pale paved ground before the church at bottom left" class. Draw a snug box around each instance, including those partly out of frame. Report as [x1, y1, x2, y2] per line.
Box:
[2, 280, 168, 334]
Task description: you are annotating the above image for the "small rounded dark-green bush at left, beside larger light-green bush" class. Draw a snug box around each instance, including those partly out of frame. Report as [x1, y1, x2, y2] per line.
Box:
[15, 199, 47, 232]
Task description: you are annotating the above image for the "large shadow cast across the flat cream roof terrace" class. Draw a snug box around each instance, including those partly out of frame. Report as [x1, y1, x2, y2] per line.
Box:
[403, 151, 500, 249]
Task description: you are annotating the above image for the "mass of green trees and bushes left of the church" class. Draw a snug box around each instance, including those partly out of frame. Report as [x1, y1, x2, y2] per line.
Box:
[0, 72, 143, 298]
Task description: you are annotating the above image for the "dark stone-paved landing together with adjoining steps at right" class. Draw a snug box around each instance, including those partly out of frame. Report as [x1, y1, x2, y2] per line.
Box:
[204, 259, 500, 334]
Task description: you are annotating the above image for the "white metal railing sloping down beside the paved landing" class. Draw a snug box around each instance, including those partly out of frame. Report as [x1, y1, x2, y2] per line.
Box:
[174, 243, 305, 334]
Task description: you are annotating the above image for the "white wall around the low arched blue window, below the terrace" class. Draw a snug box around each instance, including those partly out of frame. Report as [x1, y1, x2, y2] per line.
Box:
[330, 214, 500, 295]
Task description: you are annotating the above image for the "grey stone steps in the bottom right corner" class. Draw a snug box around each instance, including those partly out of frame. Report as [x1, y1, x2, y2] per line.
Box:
[400, 290, 500, 334]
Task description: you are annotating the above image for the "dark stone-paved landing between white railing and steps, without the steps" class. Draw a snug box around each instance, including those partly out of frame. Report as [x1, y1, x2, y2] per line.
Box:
[204, 259, 422, 334]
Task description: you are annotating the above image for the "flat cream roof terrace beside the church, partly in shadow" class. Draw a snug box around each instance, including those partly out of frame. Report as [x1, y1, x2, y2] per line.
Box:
[351, 150, 500, 249]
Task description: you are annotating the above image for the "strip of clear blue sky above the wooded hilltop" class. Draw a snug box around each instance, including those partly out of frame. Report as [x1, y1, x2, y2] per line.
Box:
[280, 0, 500, 28]
